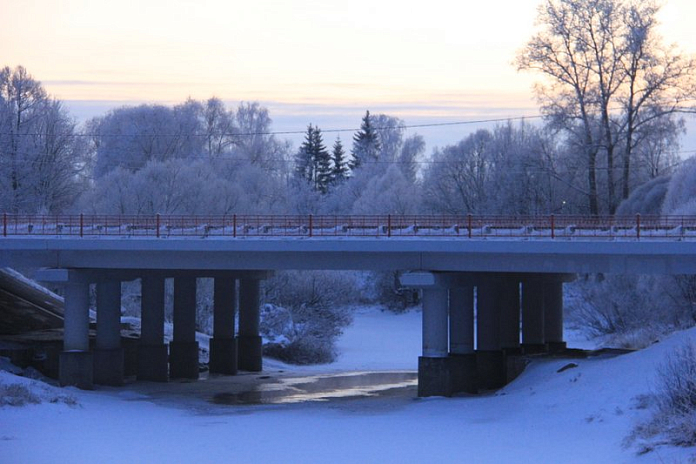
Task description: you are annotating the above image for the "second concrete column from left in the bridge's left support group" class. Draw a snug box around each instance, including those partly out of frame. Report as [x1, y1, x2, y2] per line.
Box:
[94, 280, 124, 386]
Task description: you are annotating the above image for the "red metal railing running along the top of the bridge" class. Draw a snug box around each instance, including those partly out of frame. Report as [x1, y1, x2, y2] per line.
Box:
[2, 213, 696, 240]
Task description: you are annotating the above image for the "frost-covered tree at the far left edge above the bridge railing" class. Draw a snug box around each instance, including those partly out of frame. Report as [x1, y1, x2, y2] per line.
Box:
[0, 66, 86, 213]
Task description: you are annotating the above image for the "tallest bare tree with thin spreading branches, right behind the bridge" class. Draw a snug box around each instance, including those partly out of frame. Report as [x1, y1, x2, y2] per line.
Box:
[517, 0, 696, 214]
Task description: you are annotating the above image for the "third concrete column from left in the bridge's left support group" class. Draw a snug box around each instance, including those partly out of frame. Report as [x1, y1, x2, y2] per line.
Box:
[137, 275, 169, 382]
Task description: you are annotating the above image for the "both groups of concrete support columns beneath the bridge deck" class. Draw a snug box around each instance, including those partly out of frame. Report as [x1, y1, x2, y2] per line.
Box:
[37, 269, 572, 396]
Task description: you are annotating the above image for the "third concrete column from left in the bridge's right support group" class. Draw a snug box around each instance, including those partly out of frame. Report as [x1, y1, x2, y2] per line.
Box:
[476, 276, 507, 389]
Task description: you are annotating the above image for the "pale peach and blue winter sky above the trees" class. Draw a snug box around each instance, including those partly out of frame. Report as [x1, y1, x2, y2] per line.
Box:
[0, 0, 696, 148]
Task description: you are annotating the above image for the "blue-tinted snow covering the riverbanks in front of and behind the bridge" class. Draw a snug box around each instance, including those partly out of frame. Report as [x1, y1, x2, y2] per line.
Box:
[0, 309, 696, 464]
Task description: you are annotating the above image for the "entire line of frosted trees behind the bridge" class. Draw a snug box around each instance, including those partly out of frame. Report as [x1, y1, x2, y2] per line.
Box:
[0, 0, 696, 215]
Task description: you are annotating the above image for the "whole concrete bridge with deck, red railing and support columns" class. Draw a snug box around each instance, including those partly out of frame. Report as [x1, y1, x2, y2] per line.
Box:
[0, 214, 696, 396]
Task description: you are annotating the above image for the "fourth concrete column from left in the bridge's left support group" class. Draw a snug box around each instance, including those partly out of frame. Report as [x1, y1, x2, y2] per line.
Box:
[169, 276, 198, 379]
